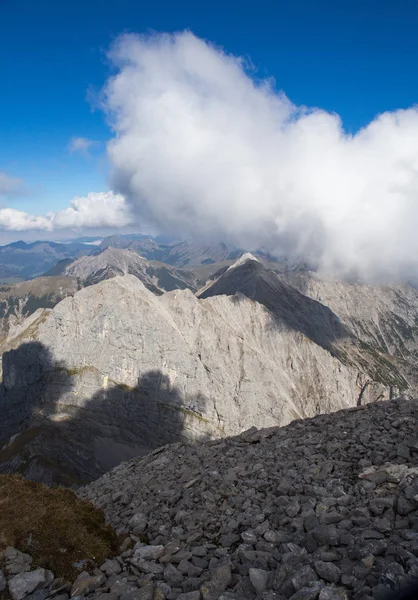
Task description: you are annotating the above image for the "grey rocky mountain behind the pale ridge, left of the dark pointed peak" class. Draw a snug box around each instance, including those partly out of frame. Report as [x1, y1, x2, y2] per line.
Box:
[61, 246, 198, 294]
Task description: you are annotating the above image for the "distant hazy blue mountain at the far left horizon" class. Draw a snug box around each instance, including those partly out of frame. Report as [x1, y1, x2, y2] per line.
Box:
[0, 241, 95, 283]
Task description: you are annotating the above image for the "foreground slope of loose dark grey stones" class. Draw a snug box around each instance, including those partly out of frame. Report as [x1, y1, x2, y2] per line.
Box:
[69, 399, 418, 600]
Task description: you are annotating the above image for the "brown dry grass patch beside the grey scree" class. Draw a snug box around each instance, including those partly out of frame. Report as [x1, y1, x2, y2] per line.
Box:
[0, 475, 119, 579]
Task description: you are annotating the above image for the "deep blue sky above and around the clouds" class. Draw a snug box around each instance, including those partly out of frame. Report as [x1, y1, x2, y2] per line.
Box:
[0, 0, 418, 241]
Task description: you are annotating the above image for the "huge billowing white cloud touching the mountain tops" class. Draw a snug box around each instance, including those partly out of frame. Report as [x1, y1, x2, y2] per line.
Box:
[103, 32, 418, 278]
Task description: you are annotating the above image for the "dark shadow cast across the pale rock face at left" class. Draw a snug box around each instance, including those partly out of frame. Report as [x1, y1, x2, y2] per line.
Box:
[0, 342, 210, 485]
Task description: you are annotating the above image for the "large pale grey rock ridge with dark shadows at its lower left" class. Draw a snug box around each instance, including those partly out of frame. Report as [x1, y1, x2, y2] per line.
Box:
[0, 270, 403, 483]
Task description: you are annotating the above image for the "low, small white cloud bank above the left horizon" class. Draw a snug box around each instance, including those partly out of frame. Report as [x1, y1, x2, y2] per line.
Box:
[0, 192, 133, 231]
